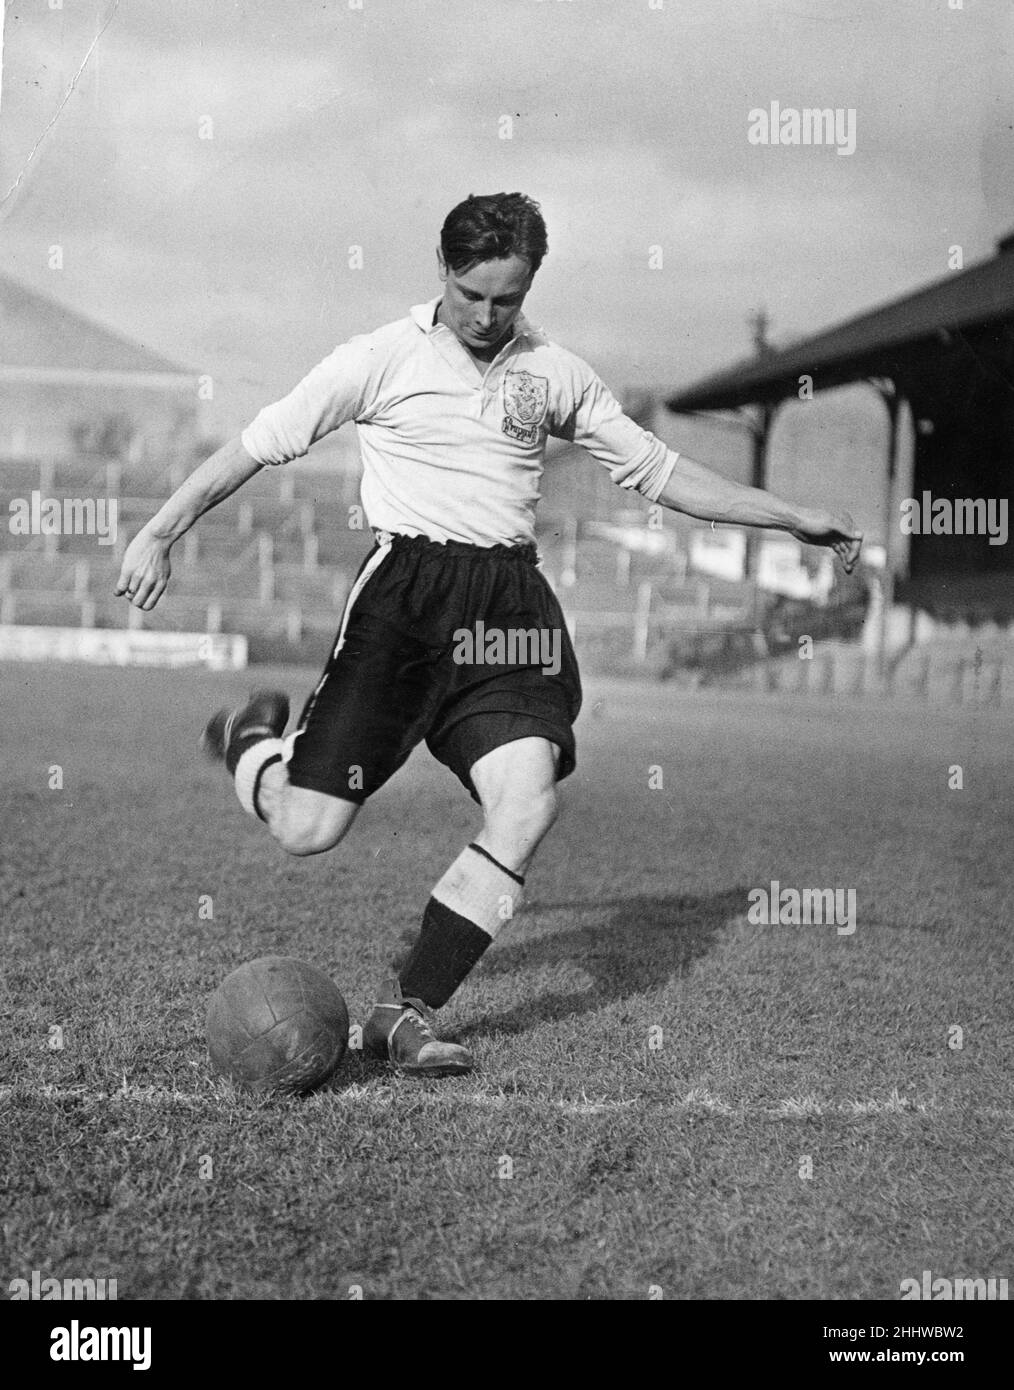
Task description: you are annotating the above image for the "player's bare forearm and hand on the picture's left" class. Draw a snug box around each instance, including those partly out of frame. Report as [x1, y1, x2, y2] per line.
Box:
[115, 438, 263, 612]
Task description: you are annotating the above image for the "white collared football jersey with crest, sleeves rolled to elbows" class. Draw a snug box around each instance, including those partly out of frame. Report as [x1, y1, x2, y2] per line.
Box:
[241, 299, 677, 545]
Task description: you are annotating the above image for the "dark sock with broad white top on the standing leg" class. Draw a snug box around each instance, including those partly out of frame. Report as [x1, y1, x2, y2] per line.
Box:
[399, 844, 524, 1009]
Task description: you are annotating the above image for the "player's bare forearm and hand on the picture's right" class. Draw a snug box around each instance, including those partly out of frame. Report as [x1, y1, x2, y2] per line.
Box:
[658, 455, 862, 574]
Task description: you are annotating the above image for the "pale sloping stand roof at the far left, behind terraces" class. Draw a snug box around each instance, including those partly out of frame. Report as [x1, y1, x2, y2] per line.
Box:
[0, 275, 195, 379]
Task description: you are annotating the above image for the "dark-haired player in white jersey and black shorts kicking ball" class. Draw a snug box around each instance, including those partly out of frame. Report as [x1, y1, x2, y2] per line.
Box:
[115, 193, 862, 1074]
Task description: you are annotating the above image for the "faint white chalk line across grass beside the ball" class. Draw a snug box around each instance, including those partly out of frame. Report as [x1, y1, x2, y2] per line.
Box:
[0, 1083, 1014, 1120]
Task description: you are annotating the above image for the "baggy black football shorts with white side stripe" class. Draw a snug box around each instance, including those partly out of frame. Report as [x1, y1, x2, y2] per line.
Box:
[288, 532, 581, 802]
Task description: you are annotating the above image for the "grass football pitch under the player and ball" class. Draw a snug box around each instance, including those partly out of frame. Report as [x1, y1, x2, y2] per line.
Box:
[0, 666, 1014, 1300]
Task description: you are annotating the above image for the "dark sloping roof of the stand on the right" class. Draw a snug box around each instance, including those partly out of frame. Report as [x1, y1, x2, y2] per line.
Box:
[666, 232, 1014, 413]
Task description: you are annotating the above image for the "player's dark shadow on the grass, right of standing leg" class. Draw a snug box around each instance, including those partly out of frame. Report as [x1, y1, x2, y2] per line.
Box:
[455, 888, 747, 1037]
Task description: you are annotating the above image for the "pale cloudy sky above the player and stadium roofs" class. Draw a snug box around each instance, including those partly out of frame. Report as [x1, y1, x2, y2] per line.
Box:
[0, 0, 1014, 450]
